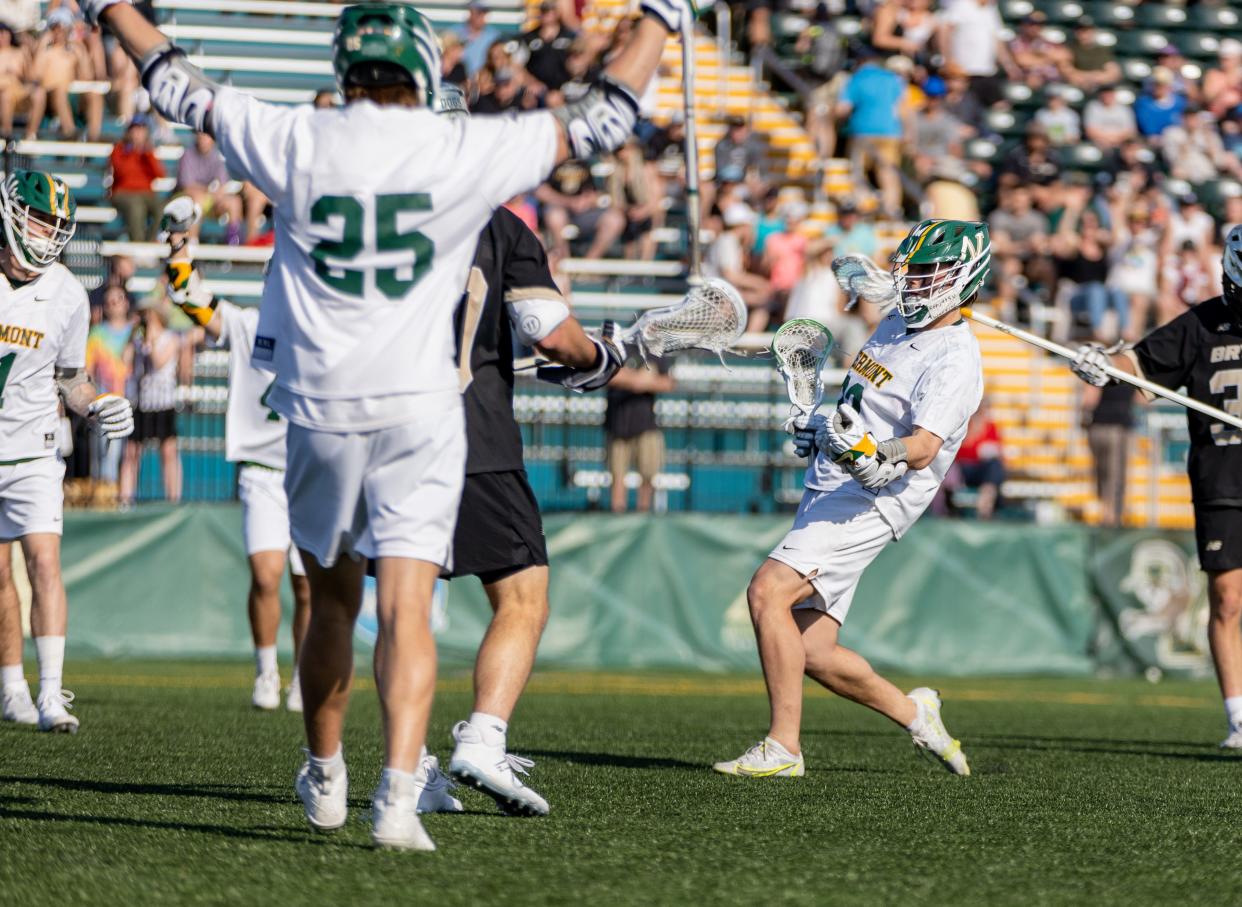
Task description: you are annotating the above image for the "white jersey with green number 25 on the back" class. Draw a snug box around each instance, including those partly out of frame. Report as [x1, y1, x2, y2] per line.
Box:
[211, 88, 559, 431]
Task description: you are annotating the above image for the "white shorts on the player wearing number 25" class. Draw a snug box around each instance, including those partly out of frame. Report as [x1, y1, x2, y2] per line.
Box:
[284, 407, 466, 568]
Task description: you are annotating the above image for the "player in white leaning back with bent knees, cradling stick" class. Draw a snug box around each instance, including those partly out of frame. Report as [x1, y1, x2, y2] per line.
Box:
[714, 220, 991, 778]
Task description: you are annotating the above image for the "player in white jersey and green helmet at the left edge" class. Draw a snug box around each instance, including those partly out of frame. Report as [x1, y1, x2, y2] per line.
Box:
[0, 170, 134, 733]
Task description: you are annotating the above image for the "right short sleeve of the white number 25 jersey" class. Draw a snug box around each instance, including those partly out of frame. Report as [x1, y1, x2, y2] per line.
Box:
[462, 111, 559, 207]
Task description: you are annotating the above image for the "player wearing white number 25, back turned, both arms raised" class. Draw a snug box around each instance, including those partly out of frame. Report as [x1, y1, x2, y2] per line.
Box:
[90, 0, 696, 850]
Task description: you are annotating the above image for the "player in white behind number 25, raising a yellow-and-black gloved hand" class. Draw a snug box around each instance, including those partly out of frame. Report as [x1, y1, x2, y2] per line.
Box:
[161, 195, 311, 712]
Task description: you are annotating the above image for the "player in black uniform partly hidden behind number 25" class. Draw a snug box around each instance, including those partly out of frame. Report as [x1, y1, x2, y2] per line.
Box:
[428, 87, 625, 815]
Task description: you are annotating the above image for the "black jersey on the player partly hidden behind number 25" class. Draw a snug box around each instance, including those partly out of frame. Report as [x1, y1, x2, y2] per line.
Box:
[456, 207, 560, 476]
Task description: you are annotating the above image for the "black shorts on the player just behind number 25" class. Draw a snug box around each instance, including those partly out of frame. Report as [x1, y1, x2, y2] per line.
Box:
[442, 470, 548, 584]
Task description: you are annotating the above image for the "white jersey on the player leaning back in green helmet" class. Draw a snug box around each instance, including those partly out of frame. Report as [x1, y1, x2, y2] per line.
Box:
[806, 311, 984, 538]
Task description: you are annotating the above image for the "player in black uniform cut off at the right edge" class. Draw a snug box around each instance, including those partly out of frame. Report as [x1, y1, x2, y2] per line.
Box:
[1073, 226, 1242, 749]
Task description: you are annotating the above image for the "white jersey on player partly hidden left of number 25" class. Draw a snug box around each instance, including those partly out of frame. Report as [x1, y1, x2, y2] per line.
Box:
[215, 299, 289, 470]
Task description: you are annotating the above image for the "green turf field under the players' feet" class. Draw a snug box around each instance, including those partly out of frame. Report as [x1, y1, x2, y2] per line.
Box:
[0, 662, 1242, 905]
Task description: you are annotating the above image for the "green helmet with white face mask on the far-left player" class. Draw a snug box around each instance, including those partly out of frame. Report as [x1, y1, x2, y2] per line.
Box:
[0, 170, 77, 273]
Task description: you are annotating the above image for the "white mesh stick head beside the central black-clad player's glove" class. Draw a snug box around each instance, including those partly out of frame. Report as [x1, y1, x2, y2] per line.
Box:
[620, 278, 746, 357]
